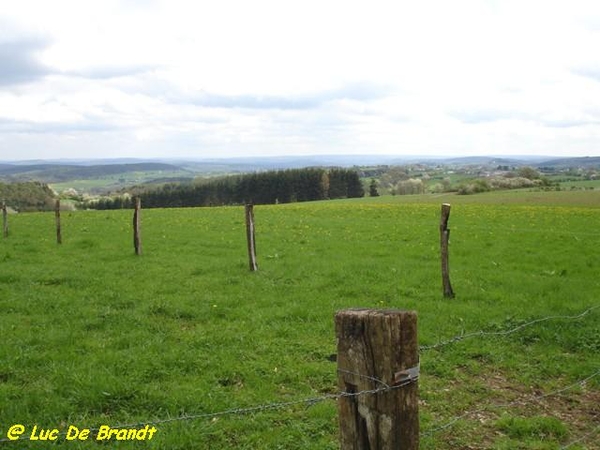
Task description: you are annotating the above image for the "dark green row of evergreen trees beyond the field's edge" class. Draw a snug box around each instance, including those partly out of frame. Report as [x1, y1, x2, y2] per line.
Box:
[88, 168, 365, 209]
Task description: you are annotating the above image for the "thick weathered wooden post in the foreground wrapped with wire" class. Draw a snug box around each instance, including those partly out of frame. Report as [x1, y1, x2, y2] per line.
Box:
[335, 309, 419, 450]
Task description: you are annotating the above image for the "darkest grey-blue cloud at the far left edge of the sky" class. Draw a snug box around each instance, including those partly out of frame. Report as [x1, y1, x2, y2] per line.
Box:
[0, 39, 51, 86]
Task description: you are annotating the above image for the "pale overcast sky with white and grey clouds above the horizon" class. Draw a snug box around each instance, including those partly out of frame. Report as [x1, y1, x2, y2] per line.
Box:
[0, 0, 600, 160]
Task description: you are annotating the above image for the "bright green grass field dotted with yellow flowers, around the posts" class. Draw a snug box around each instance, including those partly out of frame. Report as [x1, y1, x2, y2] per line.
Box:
[0, 191, 600, 449]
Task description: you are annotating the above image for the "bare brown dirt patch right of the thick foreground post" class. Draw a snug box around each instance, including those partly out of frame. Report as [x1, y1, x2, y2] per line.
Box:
[426, 373, 600, 450]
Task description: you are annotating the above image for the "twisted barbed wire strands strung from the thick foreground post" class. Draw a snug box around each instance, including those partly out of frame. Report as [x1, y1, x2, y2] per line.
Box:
[0, 305, 600, 450]
